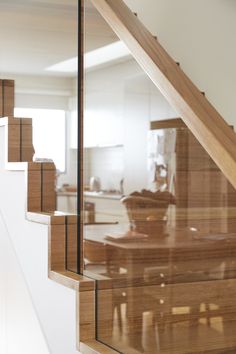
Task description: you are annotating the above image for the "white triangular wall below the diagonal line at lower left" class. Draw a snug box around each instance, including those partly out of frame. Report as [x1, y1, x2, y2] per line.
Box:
[0, 211, 49, 354]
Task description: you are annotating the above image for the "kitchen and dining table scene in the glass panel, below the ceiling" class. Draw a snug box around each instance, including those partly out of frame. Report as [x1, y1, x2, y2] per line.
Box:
[84, 1, 236, 354]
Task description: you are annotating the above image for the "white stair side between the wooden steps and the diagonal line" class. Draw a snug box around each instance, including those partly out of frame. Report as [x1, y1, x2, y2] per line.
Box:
[0, 128, 78, 354]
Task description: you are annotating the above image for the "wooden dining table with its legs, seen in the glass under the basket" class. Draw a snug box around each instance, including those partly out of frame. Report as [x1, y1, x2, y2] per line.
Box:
[85, 225, 236, 349]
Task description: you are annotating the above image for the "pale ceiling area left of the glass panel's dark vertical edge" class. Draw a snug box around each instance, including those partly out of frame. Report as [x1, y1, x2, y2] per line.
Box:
[0, 0, 77, 76]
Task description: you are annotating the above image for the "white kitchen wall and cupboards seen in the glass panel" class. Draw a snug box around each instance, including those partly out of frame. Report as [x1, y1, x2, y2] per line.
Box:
[84, 59, 177, 194]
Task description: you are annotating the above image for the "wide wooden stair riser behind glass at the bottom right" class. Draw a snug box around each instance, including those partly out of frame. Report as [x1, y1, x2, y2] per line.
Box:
[95, 279, 236, 354]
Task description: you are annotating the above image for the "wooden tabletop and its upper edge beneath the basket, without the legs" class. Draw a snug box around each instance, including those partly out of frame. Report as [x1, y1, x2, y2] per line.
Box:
[85, 225, 236, 285]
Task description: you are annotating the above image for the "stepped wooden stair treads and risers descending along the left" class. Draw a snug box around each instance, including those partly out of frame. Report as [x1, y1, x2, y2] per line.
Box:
[0, 80, 99, 349]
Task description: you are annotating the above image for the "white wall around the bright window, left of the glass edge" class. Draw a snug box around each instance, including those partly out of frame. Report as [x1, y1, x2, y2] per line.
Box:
[1, 74, 77, 185]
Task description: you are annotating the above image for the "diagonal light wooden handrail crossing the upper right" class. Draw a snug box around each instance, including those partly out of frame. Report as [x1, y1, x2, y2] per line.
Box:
[92, 0, 236, 188]
